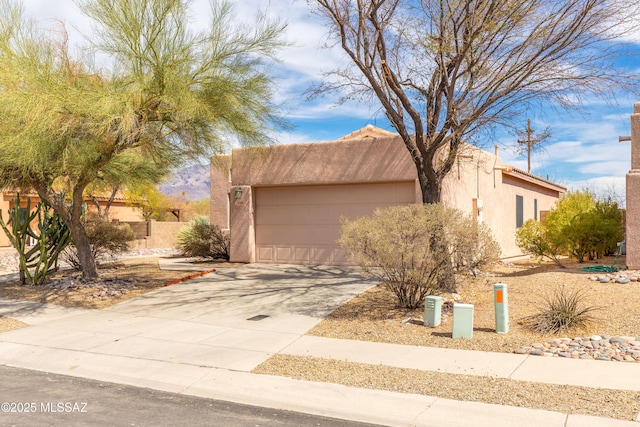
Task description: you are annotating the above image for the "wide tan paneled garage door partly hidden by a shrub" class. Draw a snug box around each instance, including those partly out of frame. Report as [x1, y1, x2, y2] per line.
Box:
[255, 182, 415, 265]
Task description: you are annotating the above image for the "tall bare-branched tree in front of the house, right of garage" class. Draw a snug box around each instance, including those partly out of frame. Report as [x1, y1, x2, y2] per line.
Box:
[310, 0, 640, 203]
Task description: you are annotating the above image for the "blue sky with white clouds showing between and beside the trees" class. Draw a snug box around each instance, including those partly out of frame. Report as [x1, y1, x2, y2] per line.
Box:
[23, 0, 640, 204]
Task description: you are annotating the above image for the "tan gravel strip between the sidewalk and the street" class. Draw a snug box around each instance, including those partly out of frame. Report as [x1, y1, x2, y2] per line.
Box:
[253, 355, 640, 420]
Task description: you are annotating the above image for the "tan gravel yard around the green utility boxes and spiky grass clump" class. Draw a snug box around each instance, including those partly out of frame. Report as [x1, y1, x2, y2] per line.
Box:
[309, 258, 640, 353]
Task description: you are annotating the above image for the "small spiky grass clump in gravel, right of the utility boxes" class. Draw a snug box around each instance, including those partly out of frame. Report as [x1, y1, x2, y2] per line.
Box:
[520, 286, 599, 334]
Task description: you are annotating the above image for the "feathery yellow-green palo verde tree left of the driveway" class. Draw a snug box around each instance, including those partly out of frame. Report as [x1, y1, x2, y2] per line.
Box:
[0, 0, 283, 277]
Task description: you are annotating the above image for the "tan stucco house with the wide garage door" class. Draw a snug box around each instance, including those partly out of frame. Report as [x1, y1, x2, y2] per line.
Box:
[211, 125, 566, 264]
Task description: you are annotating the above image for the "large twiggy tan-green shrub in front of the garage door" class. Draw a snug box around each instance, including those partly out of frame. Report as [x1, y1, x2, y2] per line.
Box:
[338, 204, 499, 308]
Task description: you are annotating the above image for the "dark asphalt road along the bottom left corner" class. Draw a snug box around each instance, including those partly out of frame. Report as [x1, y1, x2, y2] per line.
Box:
[0, 365, 382, 427]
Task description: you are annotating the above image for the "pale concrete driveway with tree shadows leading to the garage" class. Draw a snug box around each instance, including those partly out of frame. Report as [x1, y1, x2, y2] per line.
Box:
[0, 264, 373, 372]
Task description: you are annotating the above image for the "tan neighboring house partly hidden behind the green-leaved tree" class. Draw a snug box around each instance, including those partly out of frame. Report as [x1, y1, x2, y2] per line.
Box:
[0, 191, 143, 247]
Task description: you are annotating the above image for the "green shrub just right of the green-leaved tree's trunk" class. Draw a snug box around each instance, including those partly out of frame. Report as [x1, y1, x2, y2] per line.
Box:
[63, 214, 136, 269]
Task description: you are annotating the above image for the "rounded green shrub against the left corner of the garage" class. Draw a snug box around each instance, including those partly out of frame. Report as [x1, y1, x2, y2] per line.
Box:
[178, 216, 229, 260]
